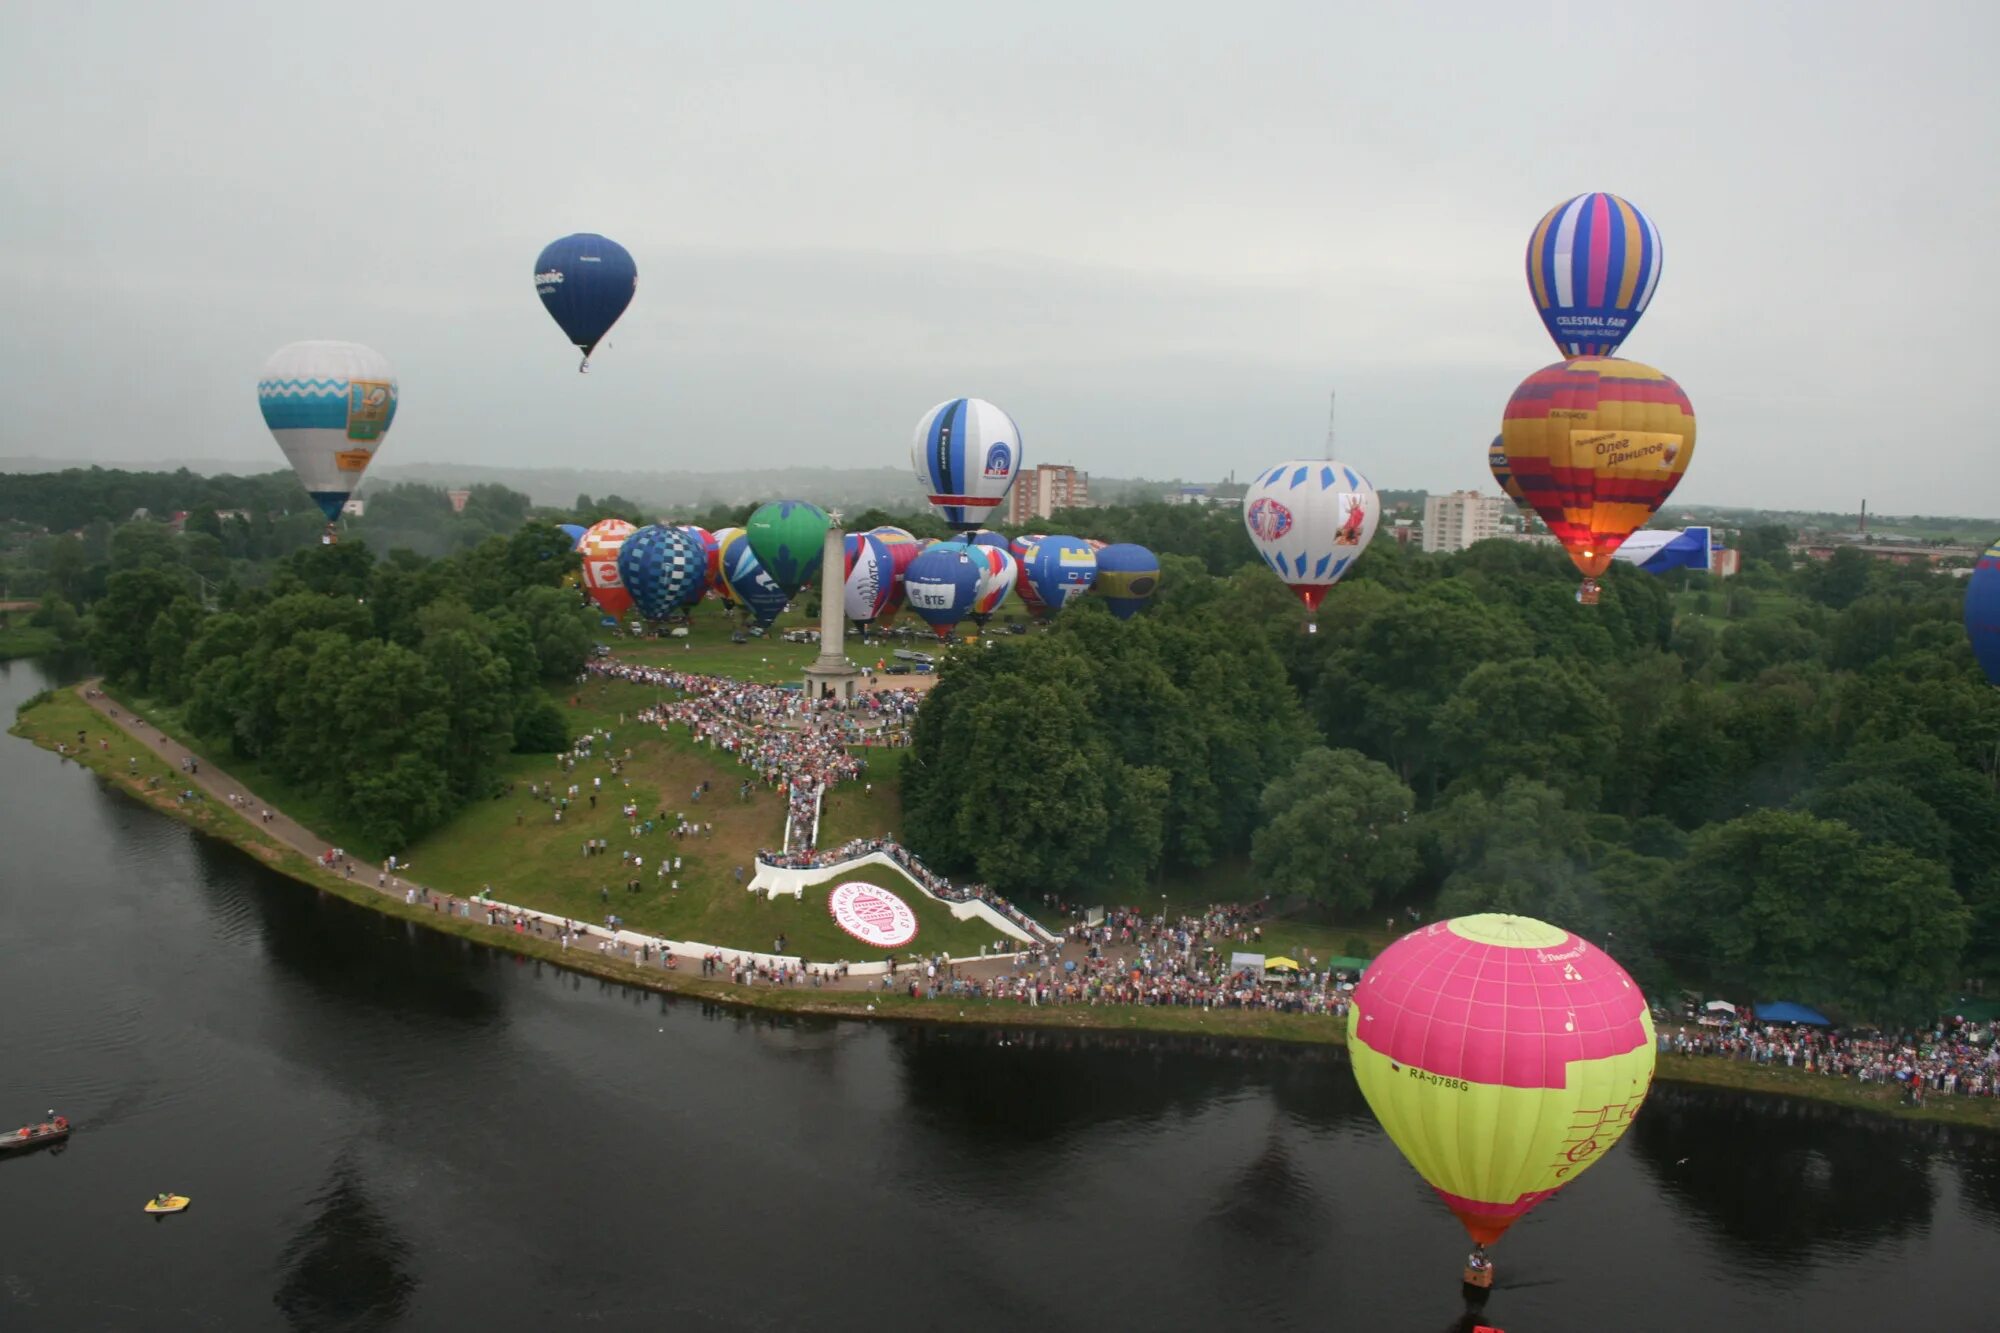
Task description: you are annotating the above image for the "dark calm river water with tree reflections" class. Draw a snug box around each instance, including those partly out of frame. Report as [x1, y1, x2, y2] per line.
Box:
[0, 662, 2000, 1333]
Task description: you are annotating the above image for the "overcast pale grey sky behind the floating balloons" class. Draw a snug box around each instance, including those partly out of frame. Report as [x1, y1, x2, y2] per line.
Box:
[0, 0, 2000, 514]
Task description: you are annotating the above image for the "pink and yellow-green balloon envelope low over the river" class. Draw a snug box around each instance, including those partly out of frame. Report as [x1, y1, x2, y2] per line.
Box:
[1348, 915, 1654, 1272]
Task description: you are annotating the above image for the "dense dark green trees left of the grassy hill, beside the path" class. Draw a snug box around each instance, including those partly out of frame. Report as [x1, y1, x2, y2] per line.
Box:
[88, 524, 596, 849]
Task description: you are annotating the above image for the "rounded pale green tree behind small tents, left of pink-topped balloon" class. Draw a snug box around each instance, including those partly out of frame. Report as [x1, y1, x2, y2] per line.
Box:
[1250, 747, 1418, 911]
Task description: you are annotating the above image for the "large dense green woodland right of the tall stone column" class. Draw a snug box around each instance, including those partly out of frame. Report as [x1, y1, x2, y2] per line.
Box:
[904, 528, 2000, 1019]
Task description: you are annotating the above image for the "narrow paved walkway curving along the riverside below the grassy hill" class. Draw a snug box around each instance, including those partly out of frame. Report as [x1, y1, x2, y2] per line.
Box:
[76, 679, 1080, 991]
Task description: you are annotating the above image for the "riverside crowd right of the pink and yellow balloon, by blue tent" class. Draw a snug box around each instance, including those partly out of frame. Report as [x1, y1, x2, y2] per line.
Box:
[1660, 1019, 2000, 1105]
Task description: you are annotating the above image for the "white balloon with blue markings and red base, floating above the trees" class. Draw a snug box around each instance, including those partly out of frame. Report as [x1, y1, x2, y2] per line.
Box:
[1244, 458, 1382, 632]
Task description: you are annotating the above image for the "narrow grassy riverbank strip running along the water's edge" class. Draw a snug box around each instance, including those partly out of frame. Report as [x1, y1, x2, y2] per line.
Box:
[12, 685, 2000, 1129]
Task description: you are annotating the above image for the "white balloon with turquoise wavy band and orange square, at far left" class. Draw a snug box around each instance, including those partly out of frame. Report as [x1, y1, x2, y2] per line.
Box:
[256, 342, 396, 538]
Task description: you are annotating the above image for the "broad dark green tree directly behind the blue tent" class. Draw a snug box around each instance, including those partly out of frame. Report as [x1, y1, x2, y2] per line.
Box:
[1680, 811, 1970, 1021]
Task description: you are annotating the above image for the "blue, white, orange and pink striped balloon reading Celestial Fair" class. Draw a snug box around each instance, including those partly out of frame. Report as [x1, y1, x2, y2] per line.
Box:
[1528, 194, 1660, 356]
